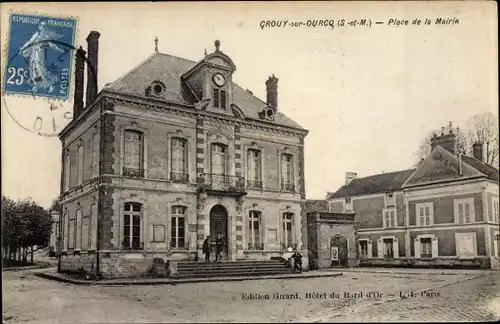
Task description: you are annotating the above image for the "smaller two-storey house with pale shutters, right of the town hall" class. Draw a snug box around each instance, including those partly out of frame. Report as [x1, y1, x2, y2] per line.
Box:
[326, 123, 500, 268]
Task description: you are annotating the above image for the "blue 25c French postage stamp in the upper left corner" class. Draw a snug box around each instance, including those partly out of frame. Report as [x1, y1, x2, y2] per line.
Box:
[2, 13, 77, 100]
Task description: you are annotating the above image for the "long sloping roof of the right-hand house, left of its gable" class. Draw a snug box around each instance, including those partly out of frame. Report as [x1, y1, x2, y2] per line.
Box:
[327, 169, 415, 199]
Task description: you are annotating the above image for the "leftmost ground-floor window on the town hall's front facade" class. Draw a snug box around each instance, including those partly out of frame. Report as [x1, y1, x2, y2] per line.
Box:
[123, 203, 142, 250]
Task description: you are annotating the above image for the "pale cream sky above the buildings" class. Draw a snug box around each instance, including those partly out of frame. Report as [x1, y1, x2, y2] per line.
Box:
[0, 1, 498, 207]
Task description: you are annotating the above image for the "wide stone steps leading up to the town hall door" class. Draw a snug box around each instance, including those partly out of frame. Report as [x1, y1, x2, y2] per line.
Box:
[175, 260, 292, 279]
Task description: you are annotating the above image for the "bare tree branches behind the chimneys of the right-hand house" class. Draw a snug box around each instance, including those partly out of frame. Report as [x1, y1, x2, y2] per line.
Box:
[414, 113, 498, 168]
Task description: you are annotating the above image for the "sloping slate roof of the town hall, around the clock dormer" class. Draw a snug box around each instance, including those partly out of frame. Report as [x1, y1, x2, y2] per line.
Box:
[105, 53, 303, 129]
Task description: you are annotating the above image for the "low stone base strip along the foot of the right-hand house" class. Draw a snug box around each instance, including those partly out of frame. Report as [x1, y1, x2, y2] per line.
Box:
[359, 257, 491, 269]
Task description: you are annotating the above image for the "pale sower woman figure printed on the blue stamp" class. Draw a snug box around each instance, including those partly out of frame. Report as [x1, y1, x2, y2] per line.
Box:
[19, 21, 65, 93]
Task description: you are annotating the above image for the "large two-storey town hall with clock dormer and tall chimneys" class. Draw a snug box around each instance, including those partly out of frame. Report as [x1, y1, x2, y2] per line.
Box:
[59, 32, 308, 277]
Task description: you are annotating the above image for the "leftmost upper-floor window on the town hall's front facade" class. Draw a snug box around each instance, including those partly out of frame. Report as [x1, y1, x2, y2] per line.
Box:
[123, 130, 144, 177]
